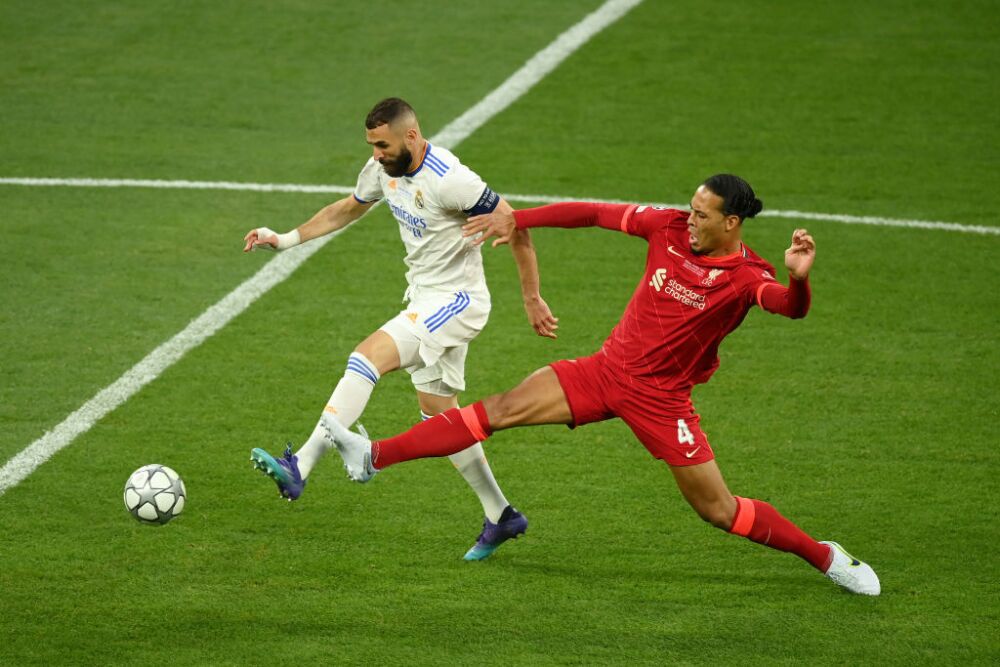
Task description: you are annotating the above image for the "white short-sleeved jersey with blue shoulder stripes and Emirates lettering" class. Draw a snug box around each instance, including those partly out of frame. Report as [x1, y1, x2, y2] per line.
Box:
[354, 142, 500, 294]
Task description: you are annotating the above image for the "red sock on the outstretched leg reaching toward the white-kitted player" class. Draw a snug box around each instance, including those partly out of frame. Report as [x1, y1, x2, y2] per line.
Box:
[372, 402, 493, 470]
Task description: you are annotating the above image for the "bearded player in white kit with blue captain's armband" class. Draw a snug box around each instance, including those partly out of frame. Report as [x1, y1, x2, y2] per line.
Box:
[244, 98, 558, 560]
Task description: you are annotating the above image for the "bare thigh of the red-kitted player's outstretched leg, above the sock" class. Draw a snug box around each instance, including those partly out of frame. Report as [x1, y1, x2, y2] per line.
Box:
[483, 366, 573, 431]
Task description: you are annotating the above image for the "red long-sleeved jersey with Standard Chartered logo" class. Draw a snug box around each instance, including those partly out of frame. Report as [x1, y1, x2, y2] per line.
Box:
[515, 203, 809, 391]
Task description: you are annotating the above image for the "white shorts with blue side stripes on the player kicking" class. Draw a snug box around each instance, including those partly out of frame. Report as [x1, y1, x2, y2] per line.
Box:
[379, 287, 490, 396]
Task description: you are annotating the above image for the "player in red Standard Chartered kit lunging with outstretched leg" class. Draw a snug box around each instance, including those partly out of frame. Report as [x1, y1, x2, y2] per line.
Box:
[328, 174, 880, 595]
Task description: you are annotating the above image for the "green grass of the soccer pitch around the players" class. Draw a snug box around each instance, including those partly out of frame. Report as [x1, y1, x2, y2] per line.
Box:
[0, 0, 1000, 665]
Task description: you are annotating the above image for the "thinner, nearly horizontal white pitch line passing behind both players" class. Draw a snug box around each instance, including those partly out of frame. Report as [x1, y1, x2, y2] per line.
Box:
[0, 178, 1000, 236]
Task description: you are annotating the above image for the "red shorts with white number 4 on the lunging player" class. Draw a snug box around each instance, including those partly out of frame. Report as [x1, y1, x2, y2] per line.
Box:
[549, 352, 715, 466]
